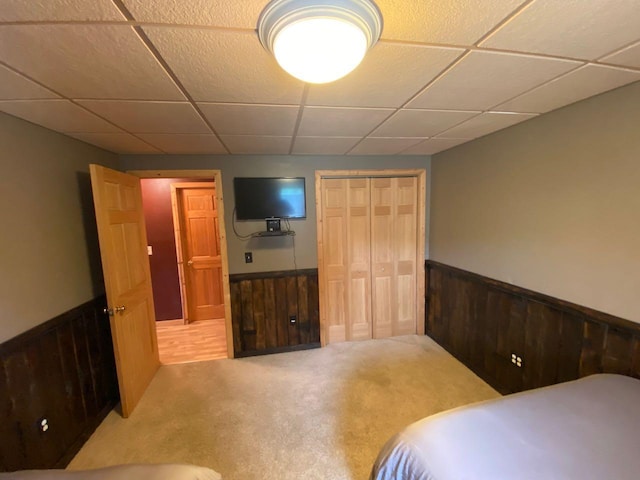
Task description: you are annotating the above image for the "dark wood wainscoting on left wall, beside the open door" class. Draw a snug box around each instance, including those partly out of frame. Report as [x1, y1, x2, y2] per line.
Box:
[0, 297, 118, 471]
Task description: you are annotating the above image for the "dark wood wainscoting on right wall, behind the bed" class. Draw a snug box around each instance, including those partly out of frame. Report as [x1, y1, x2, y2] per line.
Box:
[426, 261, 640, 393]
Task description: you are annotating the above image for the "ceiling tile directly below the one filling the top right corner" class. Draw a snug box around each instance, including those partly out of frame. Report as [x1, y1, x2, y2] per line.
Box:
[408, 51, 580, 110]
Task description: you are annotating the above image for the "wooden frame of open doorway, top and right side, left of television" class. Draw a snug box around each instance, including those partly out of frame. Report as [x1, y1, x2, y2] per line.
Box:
[127, 170, 235, 358]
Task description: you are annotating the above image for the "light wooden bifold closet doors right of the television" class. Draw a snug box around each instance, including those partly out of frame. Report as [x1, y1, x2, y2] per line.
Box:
[320, 177, 420, 343]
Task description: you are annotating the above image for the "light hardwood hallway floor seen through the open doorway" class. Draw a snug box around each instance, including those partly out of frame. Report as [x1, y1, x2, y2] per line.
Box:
[156, 318, 227, 365]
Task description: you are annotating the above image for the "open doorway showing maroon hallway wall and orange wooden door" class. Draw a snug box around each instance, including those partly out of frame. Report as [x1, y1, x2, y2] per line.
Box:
[130, 171, 233, 364]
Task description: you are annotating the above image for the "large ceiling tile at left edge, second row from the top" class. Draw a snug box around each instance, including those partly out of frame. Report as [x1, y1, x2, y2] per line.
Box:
[0, 24, 184, 100]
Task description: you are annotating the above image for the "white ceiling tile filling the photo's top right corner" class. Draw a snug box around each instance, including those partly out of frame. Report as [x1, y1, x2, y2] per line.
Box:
[480, 0, 640, 60]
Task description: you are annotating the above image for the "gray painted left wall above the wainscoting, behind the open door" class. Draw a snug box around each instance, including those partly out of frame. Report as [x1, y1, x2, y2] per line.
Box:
[0, 113, 118, 342]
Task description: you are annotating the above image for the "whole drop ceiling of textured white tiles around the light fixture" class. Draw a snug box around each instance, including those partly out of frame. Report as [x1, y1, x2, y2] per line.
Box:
[0, 0, 640, 156]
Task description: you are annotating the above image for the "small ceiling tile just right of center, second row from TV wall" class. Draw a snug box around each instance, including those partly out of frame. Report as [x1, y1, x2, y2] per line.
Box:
[298, 107, 394, 137]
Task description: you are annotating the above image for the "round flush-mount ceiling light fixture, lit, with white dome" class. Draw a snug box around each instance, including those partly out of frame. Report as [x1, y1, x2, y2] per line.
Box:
[258, 0, 382, 83]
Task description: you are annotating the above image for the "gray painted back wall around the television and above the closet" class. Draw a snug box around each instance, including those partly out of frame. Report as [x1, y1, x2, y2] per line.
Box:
[120, 155, 431, 273]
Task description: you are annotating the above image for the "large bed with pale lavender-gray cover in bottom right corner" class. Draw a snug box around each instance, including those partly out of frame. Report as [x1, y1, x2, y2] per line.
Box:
[371, 374, 640, 480]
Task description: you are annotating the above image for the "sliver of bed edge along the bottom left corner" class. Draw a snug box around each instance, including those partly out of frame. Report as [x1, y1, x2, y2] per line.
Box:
[0, 464, 222, 480]
